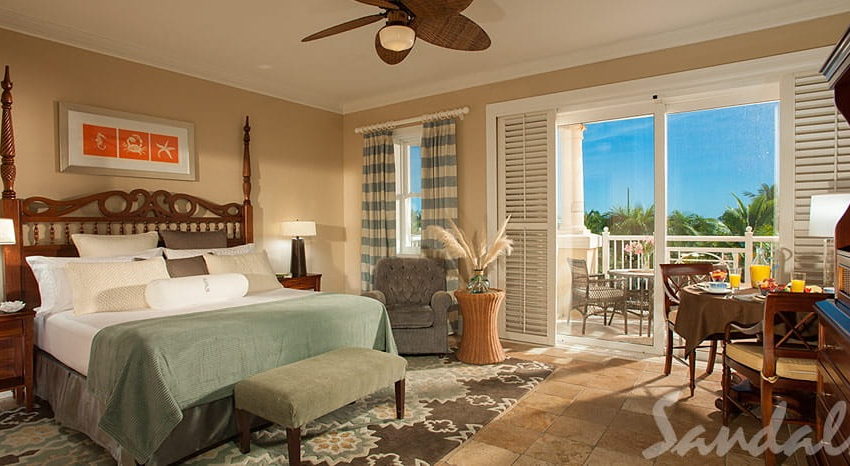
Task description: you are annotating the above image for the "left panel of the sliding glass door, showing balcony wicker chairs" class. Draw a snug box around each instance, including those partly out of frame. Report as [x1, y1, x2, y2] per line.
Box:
[557, 108, 656, 345]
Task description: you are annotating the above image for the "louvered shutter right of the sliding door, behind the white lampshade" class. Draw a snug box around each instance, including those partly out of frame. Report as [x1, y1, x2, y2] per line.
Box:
[794, 73, 850, 283]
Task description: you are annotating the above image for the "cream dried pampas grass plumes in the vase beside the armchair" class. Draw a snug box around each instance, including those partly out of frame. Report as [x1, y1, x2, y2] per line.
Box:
[425, 216, 513, 270]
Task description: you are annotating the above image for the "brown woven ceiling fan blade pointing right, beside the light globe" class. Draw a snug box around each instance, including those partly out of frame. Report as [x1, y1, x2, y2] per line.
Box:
[410, 14, 490, 51]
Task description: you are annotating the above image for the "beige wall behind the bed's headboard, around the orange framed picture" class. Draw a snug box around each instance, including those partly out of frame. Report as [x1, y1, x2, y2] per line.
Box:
[0, 29, 345, 291]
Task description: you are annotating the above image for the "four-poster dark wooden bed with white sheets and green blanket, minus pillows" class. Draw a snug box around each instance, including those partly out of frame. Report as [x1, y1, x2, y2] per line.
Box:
[0, 68, 395, 464]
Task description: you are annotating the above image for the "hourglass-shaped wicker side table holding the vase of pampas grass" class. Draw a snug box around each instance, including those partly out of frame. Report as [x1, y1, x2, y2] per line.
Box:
[455, 289, 505, 364]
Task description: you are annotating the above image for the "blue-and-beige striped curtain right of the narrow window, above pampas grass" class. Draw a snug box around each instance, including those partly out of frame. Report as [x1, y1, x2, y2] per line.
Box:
[421, 118, 459, 290]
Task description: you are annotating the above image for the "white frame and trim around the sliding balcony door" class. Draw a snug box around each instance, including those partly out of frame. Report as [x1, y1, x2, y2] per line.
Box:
[486, 47, 831, 354]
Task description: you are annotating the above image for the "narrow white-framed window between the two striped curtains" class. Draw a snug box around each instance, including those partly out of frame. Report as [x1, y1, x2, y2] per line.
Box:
[394, 127, 422, 255]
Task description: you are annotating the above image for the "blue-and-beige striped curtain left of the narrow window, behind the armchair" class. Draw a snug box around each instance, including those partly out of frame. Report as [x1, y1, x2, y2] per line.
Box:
[360, 130, 396, 291]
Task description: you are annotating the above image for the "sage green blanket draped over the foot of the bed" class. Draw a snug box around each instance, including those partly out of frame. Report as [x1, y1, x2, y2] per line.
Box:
[88, 293, 397, 463]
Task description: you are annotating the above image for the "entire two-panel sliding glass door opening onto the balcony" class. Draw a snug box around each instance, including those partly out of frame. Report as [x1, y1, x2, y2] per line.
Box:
[555, 99, 779, 351]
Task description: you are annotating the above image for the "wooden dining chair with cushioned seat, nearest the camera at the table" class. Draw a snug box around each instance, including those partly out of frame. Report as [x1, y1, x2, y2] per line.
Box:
[722, 293, 832, 465]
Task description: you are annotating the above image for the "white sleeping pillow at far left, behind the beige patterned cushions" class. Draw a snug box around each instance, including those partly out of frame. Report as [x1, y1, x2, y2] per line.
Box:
[27, 248, 162, 312]
